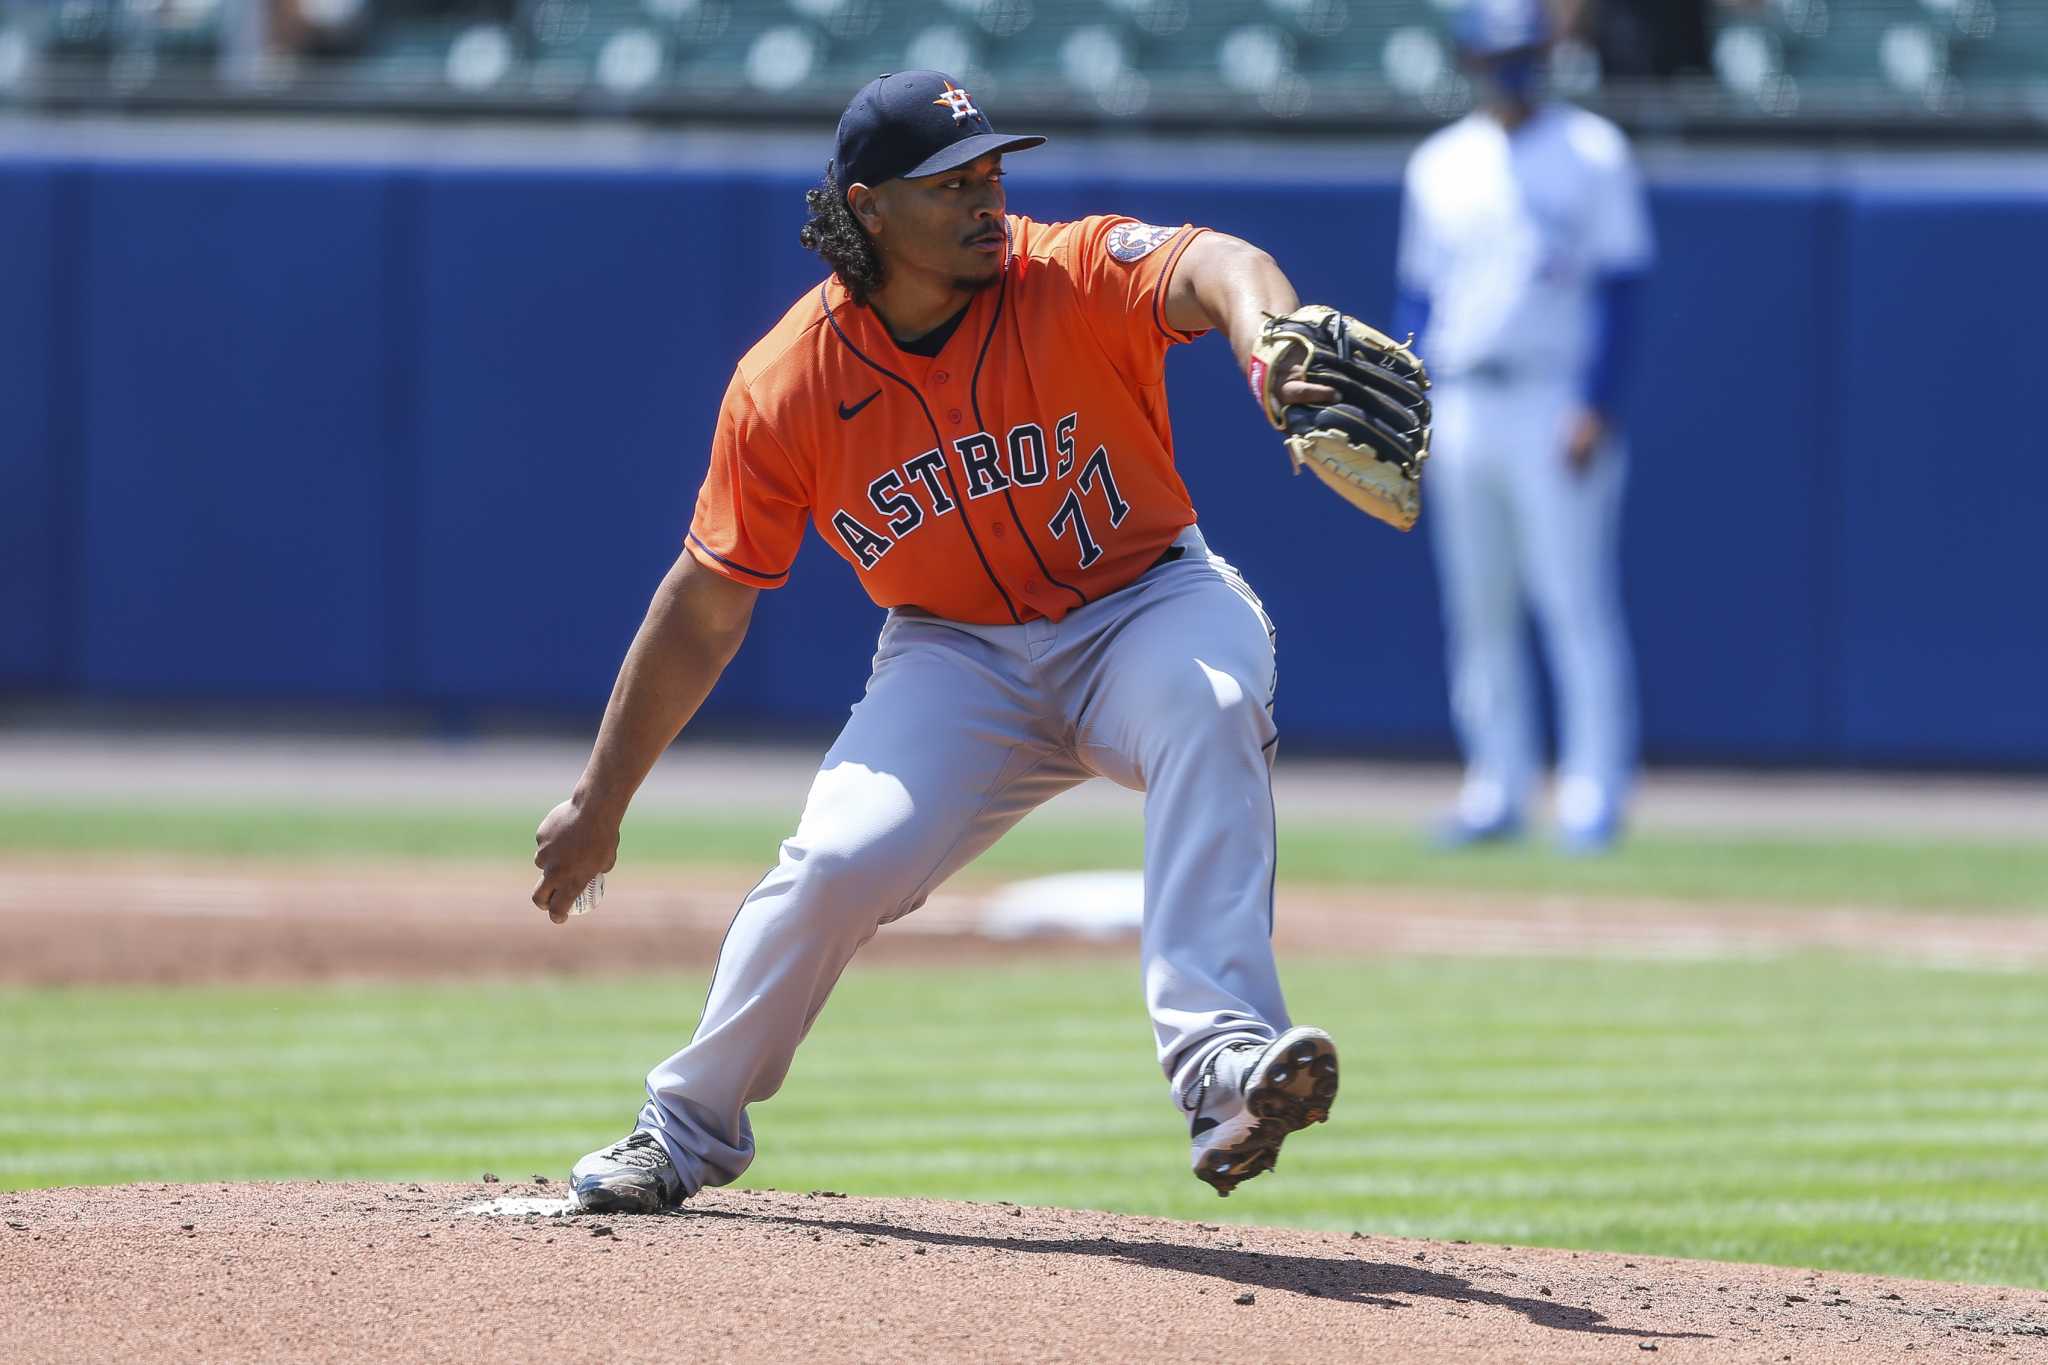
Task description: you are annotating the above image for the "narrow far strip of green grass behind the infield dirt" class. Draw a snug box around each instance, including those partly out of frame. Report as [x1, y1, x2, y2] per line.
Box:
[0, 802, 2048, 911]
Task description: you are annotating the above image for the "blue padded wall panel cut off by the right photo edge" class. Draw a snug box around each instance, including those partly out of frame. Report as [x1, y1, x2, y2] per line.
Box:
[1837, 190, 2048, 763]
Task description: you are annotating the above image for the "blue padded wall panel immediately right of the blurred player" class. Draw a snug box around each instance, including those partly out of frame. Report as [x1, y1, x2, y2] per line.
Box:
[1622, 188, 1841, 757]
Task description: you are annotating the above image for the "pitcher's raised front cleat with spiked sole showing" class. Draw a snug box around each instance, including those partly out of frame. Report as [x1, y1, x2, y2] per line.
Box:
[1188, 1027, 1337, 1195]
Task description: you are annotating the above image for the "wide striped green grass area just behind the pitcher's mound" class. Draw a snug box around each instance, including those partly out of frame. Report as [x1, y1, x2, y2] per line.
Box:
[0, 960, 2048, 1287]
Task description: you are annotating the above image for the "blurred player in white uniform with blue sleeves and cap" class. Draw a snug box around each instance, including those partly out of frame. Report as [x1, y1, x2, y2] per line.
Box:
[1395, 0, 1651, 853]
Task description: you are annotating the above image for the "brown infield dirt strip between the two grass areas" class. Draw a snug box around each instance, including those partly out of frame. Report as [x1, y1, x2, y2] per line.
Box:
[0, 855, 2048, 986]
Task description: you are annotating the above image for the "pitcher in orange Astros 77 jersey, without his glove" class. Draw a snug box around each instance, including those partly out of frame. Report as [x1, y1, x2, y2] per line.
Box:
[532, 72, 1409, 1209]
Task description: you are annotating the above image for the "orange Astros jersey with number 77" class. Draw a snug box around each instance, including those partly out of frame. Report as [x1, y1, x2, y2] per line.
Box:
[688, 215, 1202, 624]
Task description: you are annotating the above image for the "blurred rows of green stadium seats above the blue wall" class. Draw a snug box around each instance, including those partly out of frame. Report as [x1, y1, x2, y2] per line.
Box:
[0, 0, 2048, 121]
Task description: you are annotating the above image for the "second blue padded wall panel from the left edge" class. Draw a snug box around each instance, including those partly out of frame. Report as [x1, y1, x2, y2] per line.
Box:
[74, 166, 393, 698]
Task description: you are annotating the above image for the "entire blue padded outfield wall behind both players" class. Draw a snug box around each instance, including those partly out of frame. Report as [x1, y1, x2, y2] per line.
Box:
[0, 160, 2048, 765]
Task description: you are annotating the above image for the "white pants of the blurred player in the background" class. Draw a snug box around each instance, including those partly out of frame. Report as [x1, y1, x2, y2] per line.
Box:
[1425, 379, 1636, 831]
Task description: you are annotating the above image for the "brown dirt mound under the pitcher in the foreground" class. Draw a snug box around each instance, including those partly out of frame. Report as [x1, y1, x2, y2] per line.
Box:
[0, 1183, 2048, 1365]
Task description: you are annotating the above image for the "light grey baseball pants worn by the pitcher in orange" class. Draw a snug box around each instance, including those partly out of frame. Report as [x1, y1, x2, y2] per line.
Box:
[639, 528, 1288, 1191]
